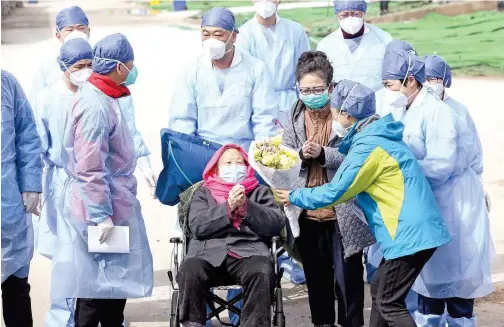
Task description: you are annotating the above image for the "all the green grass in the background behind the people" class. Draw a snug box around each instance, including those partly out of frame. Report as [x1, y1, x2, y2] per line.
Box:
[237, 2, 504, 76]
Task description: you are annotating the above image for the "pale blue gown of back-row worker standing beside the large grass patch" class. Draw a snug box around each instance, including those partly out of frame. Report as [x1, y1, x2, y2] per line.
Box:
[317, 24, 392, 91]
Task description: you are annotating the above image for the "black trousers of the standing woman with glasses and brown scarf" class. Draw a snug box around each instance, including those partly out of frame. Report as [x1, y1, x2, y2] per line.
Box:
[296, 217, 364, 327]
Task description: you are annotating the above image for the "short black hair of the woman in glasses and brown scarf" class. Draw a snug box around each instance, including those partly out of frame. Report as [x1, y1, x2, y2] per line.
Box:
[296, 51, 333, 85]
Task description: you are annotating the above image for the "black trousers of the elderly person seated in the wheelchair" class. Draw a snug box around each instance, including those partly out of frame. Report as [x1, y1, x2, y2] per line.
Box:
[177, 256, 275, 327]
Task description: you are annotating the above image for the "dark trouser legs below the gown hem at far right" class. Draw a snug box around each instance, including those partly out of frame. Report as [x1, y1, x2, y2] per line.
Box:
[418, 294, 474, 319]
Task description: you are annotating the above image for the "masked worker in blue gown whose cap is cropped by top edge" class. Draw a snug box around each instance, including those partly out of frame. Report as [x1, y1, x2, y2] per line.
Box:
[236, 0, 310, 126]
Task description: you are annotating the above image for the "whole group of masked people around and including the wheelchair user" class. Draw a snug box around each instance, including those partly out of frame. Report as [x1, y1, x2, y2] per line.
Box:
[2, 0, 493, 327]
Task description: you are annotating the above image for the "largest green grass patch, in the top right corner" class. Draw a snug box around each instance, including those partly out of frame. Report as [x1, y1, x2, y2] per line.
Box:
[379, 11, 504, 75]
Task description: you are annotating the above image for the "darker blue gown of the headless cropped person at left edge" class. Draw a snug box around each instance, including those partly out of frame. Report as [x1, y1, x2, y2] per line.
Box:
[2, 70, 42, 283]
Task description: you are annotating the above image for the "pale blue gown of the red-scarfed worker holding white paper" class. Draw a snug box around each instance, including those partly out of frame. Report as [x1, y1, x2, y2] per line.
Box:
[51, 83, 153, 299]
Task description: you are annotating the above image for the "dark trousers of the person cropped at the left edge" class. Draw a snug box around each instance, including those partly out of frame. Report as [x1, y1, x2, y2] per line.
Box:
[2, 275, 33, 327]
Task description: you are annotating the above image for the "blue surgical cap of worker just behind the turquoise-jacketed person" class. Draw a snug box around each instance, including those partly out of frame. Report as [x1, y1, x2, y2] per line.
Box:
[382, 50, 425, 83]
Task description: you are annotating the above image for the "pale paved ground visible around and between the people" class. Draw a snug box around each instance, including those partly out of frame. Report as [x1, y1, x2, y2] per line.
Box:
[1, 1, 504, 327]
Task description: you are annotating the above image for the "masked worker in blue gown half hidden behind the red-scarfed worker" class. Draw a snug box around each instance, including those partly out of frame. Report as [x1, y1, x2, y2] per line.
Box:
[34, 38, 93, 327]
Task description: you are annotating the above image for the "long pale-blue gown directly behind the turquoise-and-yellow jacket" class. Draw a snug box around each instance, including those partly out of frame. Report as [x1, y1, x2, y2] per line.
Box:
[403, 87, 493, 298]
